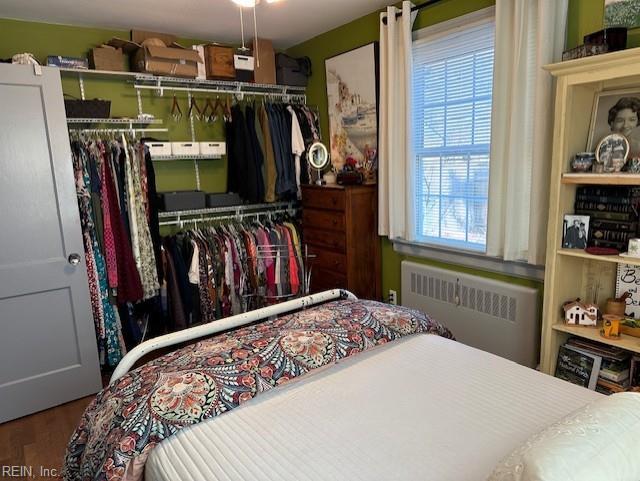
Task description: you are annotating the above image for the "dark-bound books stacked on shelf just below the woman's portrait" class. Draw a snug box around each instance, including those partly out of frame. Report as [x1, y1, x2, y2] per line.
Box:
[574, 185, 640, 252]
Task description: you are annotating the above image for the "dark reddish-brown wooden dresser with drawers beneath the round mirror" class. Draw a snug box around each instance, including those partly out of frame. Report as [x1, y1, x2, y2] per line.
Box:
[302, 185, 381, 299]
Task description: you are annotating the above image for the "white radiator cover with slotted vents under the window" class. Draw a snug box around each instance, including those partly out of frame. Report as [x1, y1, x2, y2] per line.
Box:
[401, 261, 540, 368]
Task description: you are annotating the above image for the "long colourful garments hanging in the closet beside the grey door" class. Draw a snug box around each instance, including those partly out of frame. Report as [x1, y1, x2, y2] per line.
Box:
[71, 138, 165, 367]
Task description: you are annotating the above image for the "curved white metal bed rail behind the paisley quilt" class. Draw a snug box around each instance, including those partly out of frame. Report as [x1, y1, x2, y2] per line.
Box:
[110, 289, 357, 382]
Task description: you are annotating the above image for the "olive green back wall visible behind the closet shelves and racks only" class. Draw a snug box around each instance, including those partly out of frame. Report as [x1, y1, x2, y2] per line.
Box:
[0, 19, 227, 192]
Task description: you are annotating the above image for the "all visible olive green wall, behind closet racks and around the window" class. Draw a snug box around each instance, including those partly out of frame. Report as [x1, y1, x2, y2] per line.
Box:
[0, 0, 616, 295]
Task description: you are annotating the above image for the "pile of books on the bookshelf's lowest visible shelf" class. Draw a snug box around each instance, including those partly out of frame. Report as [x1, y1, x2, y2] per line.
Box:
[555, 337, 640, 394]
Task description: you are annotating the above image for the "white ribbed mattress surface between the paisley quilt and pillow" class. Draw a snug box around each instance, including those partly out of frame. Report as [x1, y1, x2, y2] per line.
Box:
[145, 335, 601, 481]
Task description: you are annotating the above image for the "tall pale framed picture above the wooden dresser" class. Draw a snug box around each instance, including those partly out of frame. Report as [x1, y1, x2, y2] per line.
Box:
[325, 42, 379, 170]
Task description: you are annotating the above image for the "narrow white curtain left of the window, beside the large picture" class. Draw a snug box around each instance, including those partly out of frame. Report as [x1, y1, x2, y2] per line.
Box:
[378, 1, 415, 239]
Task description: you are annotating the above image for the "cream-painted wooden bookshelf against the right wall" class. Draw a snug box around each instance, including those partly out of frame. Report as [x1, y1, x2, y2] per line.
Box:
[540, 48, 640, 375]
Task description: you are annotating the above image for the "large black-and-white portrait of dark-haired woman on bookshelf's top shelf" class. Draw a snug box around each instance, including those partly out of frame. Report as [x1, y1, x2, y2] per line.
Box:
[587, 88, 640, 157]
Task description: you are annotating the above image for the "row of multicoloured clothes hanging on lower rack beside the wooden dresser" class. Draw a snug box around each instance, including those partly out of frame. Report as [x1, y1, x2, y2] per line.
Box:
[162, 215, 304, 329]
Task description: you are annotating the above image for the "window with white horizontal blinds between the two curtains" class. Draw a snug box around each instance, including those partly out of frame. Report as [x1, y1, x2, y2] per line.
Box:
[413, 18, 494, 252]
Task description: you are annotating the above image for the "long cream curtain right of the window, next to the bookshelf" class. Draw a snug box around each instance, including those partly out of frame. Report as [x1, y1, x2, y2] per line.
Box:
[487, 0, 568, 265]
